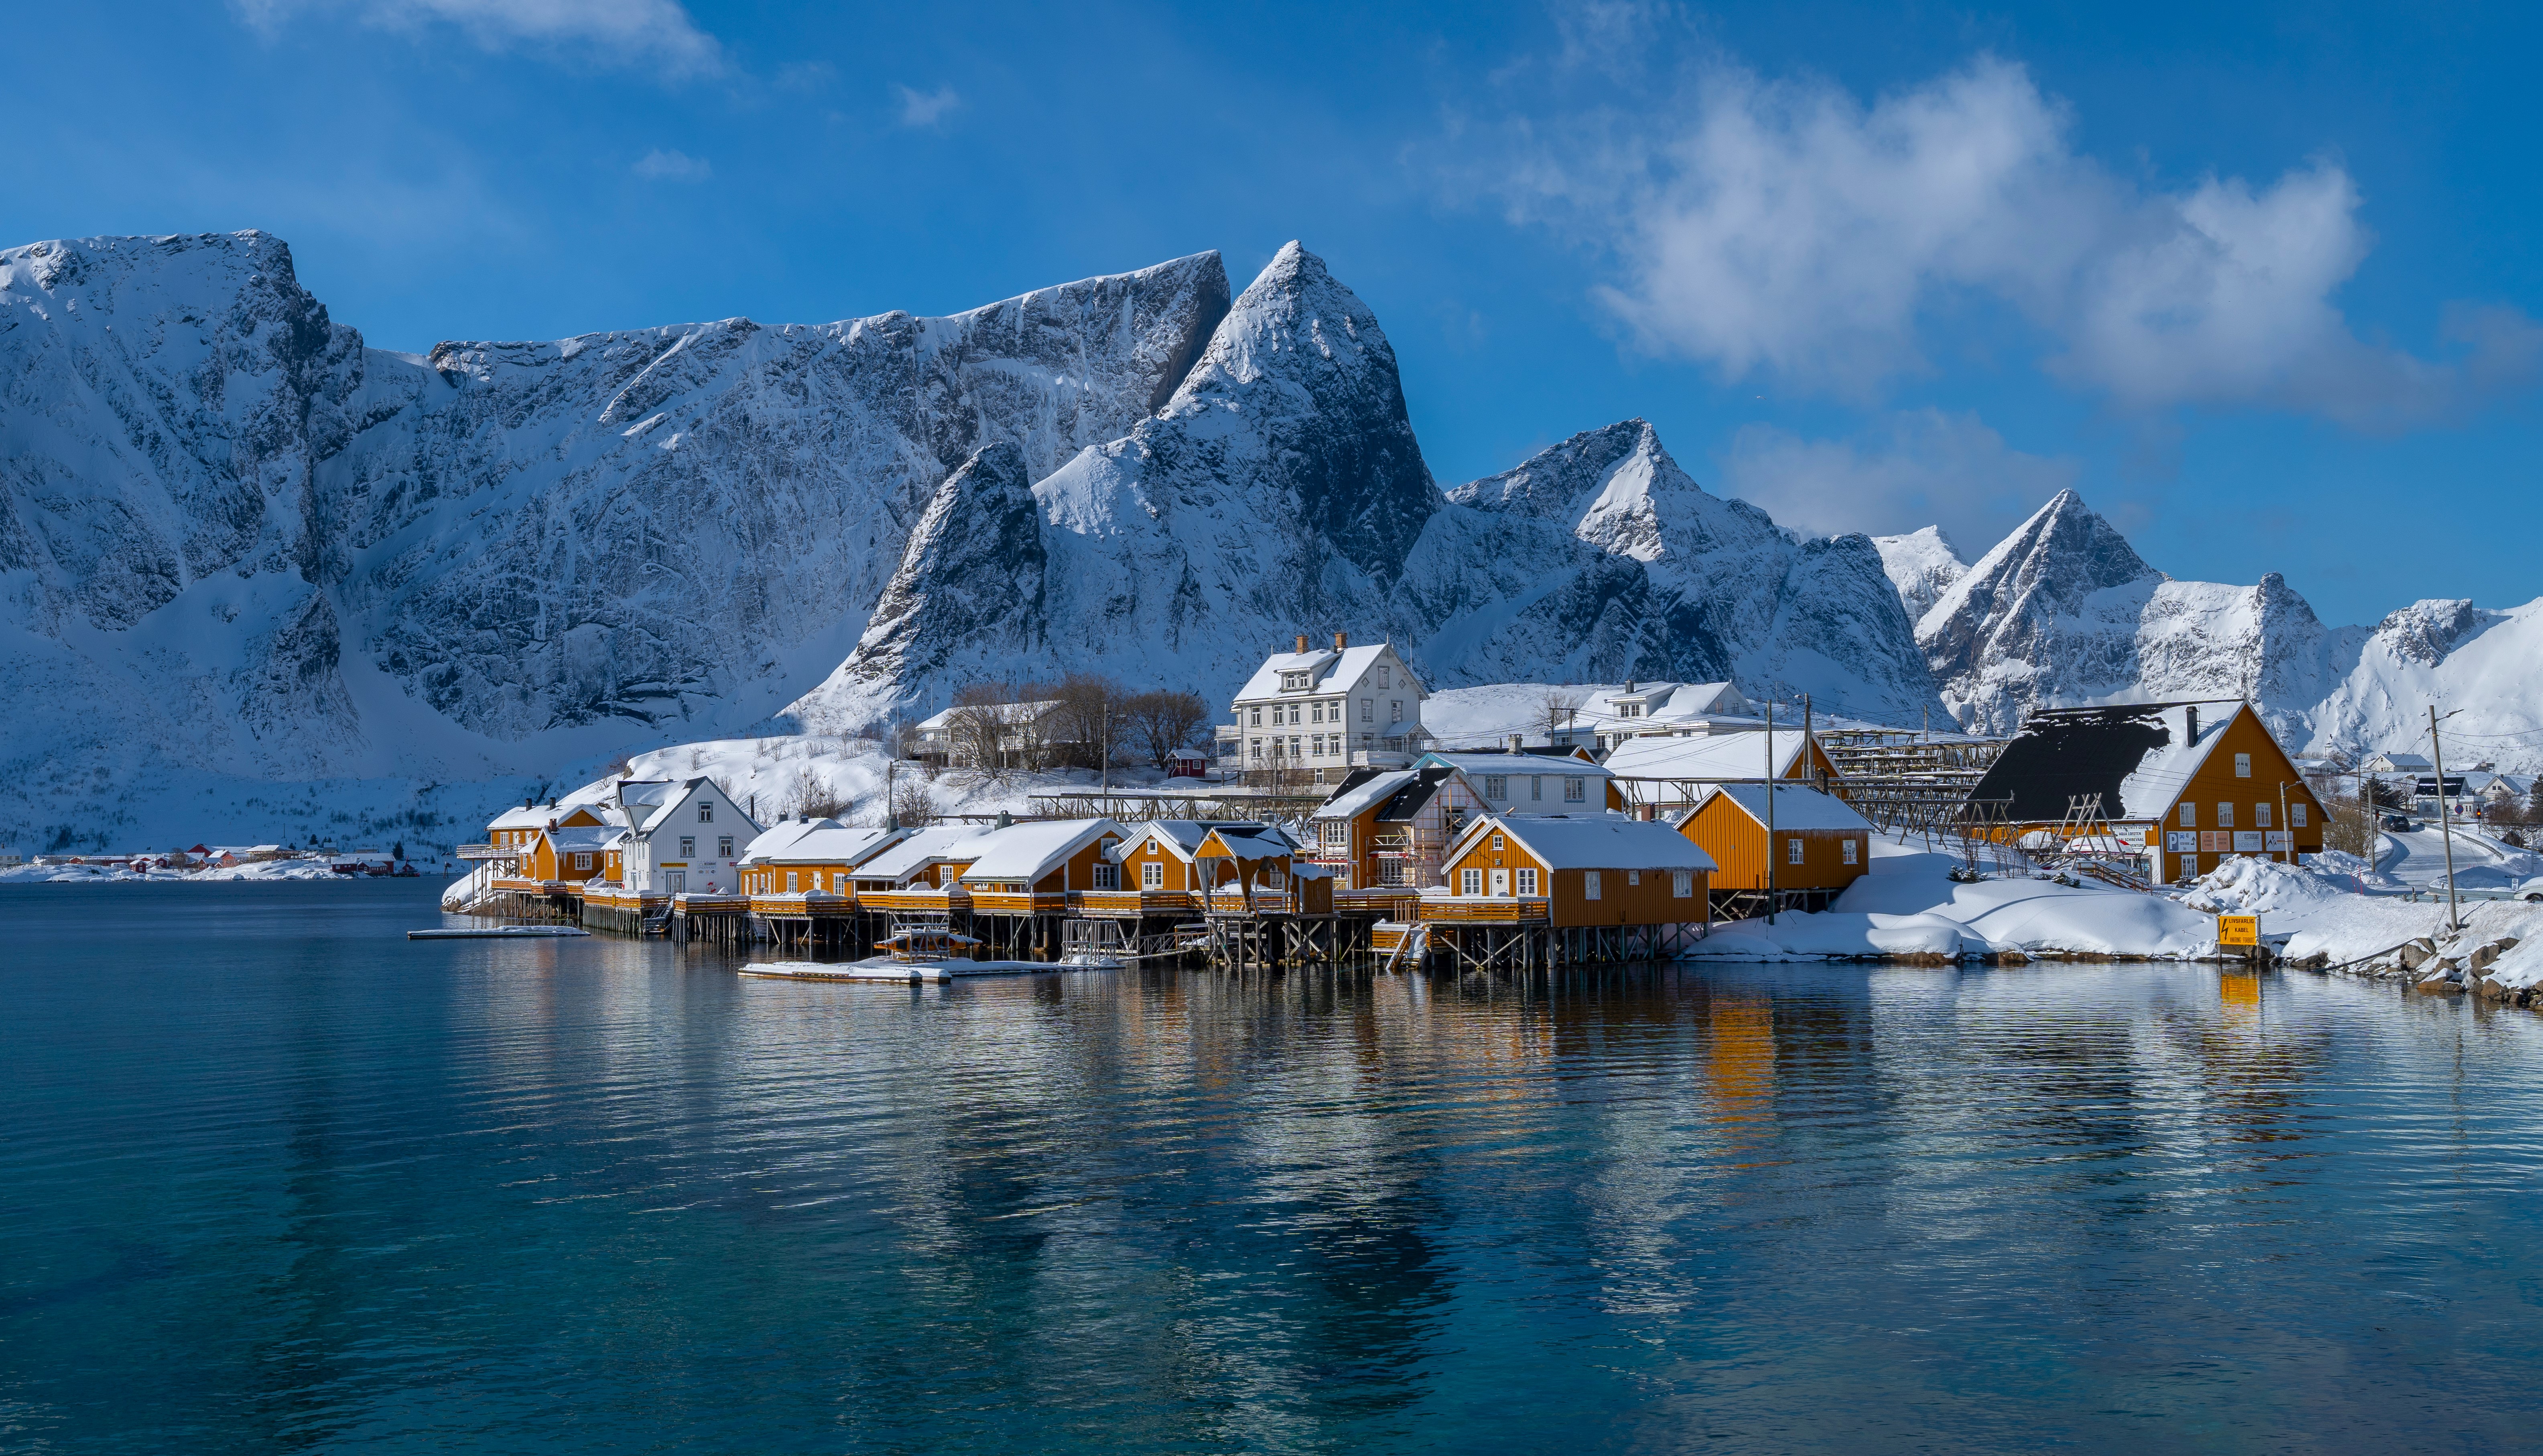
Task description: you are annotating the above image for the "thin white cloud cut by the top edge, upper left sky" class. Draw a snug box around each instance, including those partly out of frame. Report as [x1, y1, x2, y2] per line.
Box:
[232, 0, 725, 79]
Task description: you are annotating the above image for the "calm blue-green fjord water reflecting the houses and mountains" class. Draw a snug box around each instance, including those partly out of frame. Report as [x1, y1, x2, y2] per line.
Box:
[0, 882, 2543, 1451]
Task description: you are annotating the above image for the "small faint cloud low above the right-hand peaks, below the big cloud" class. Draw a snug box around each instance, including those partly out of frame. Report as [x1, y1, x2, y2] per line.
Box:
[1722, 409, 2075, 551]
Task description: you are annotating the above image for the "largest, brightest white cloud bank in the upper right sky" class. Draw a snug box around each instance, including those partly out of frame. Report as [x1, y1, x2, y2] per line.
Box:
[1488, 51, 2543, 427]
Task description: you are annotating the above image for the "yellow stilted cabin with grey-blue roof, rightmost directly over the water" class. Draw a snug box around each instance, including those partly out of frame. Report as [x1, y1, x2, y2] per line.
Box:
[1419, 813, 1714, 928]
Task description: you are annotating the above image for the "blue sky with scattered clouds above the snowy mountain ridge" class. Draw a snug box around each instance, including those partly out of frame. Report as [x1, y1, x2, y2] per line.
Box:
[0, 0, 2543, 623]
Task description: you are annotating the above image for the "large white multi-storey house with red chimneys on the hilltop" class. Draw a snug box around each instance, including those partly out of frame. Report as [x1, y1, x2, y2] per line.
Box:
[1218, 633, 1432, 783]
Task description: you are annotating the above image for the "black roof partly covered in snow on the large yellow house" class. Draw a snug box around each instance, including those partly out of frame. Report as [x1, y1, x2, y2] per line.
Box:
[1968, 699, 2276, 823]
